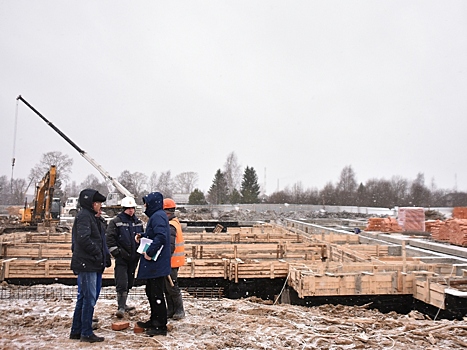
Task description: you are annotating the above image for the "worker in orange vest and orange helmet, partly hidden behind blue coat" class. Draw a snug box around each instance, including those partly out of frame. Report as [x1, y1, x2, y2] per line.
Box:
[164, 198, 185, 320]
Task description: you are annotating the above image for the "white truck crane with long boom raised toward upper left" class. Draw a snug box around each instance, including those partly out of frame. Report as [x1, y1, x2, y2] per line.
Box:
[16, 95, 134, 217]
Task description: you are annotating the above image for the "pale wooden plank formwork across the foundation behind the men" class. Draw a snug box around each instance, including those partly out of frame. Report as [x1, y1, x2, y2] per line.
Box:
[0, 225, 467, 316]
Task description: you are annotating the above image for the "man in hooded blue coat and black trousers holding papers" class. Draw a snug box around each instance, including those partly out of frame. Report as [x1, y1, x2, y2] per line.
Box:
[137, 192, 171, 336]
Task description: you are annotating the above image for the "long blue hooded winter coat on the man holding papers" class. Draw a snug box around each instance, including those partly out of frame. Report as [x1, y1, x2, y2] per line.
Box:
[137, 192, 171, 279]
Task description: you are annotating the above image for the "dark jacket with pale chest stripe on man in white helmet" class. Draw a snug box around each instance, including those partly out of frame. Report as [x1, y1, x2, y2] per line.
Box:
[106, 212, 144, 261]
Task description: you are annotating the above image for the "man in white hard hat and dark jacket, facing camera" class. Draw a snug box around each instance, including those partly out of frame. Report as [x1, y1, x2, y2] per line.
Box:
[106, 197, 144, 318]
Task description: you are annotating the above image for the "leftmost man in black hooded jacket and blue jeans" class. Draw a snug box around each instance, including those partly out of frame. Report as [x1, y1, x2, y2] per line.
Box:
[70, 189, 110, 343]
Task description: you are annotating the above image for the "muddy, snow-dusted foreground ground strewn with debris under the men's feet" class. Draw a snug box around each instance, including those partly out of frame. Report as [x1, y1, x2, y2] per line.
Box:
[0, 285, 467, 350]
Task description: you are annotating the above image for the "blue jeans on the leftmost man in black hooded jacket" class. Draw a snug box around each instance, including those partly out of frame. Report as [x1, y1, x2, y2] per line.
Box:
[71, 272, 99, 337]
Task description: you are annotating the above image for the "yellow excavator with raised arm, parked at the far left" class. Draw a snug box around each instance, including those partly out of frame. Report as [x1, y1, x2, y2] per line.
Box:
[21, 165, 60, 227]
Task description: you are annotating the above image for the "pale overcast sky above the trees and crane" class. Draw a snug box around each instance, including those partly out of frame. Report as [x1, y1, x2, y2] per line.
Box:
[0, 0, 467, 194]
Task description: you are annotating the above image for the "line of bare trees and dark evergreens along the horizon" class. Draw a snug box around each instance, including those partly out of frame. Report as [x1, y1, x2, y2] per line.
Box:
[0, 152, 467, 208]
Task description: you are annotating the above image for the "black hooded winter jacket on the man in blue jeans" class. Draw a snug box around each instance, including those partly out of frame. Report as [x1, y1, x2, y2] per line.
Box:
[71, 189, 110, 275]
